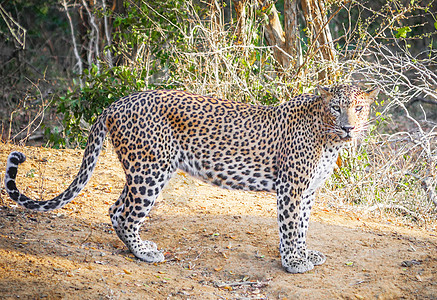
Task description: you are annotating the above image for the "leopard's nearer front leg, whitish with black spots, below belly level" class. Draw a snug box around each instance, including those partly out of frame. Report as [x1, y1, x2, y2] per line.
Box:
[277, 184, 314, 273]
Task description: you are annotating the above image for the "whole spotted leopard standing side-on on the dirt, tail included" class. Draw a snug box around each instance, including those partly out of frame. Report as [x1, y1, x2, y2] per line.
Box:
[4, 84, 379, 273]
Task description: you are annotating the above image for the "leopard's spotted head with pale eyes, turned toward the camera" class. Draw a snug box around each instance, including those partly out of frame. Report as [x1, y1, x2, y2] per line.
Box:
[318, 85, 379, 142]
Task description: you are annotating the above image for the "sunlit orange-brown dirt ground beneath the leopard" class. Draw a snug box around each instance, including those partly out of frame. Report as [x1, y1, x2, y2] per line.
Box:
[0, 144, 437, 299]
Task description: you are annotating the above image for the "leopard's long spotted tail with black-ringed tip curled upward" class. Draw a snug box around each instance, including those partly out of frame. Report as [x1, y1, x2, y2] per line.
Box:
[5, 113, 107, 211]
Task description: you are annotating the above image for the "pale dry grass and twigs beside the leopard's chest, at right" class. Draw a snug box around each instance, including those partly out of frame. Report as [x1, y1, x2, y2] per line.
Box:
[321, 133, 437, 228]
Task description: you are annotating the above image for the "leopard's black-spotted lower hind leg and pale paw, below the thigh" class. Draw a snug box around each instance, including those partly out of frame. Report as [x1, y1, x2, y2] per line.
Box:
[109, 185, 164, 263]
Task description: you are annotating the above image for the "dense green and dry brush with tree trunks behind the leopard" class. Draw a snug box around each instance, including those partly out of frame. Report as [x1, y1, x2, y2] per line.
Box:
[0, 0, 437, 225]
